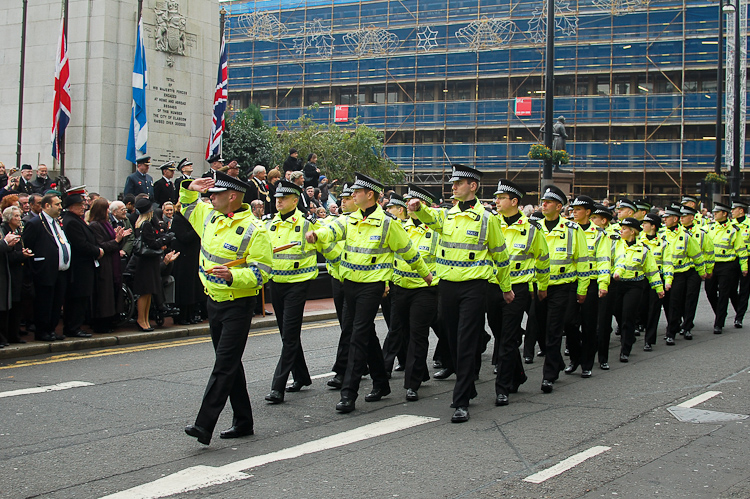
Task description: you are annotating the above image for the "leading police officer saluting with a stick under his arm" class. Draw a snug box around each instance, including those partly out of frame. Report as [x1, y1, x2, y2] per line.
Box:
[180, 172, 273, 445]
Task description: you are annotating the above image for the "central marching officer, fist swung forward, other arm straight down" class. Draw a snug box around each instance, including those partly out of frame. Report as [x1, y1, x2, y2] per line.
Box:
[407, 165, 514, 423]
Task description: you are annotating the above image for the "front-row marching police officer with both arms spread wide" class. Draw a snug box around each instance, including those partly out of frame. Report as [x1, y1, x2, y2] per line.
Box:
[306, 173, 432, 413]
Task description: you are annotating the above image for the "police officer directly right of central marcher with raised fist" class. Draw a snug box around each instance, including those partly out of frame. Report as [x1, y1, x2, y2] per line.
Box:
[494, 179, 549, 406]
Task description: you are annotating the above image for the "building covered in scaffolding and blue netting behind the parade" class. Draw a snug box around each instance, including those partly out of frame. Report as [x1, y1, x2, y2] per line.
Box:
[224, 0, 746, 204]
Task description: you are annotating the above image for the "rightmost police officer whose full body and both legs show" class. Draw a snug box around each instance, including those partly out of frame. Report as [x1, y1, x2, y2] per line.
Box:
[706, 203, 747, 334]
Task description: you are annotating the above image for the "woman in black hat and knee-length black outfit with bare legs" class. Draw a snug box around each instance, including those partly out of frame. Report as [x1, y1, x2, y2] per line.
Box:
[133, 198, 166, 331]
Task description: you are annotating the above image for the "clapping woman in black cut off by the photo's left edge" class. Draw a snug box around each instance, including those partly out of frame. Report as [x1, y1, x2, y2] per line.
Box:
[0, 206, 32, 348]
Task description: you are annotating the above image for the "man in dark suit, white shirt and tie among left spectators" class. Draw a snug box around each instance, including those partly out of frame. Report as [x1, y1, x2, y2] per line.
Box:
[23, 194, 71, 341]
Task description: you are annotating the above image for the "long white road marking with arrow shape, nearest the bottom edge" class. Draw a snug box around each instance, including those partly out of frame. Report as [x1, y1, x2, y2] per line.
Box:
[102, 415, 438, 499]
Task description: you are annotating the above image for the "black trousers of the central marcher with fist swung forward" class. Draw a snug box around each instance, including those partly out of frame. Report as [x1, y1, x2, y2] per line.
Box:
[438, 279, 488, 407]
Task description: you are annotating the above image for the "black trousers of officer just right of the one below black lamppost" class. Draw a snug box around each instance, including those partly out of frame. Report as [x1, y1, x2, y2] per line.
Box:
[565, 280, 599, 371]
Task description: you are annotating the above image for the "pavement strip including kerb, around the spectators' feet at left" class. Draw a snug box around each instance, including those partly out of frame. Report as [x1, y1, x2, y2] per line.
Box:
[0, 298, 336, 360]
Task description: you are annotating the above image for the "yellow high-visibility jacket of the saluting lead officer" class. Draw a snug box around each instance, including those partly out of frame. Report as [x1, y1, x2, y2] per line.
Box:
[180, 188, 273, 301]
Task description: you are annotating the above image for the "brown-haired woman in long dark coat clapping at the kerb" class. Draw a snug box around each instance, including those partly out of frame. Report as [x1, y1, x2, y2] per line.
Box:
[89, 197, 132, 334]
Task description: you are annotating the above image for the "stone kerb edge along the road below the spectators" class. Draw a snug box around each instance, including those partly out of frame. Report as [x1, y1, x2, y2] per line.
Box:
[0, 311, 336, 360]
